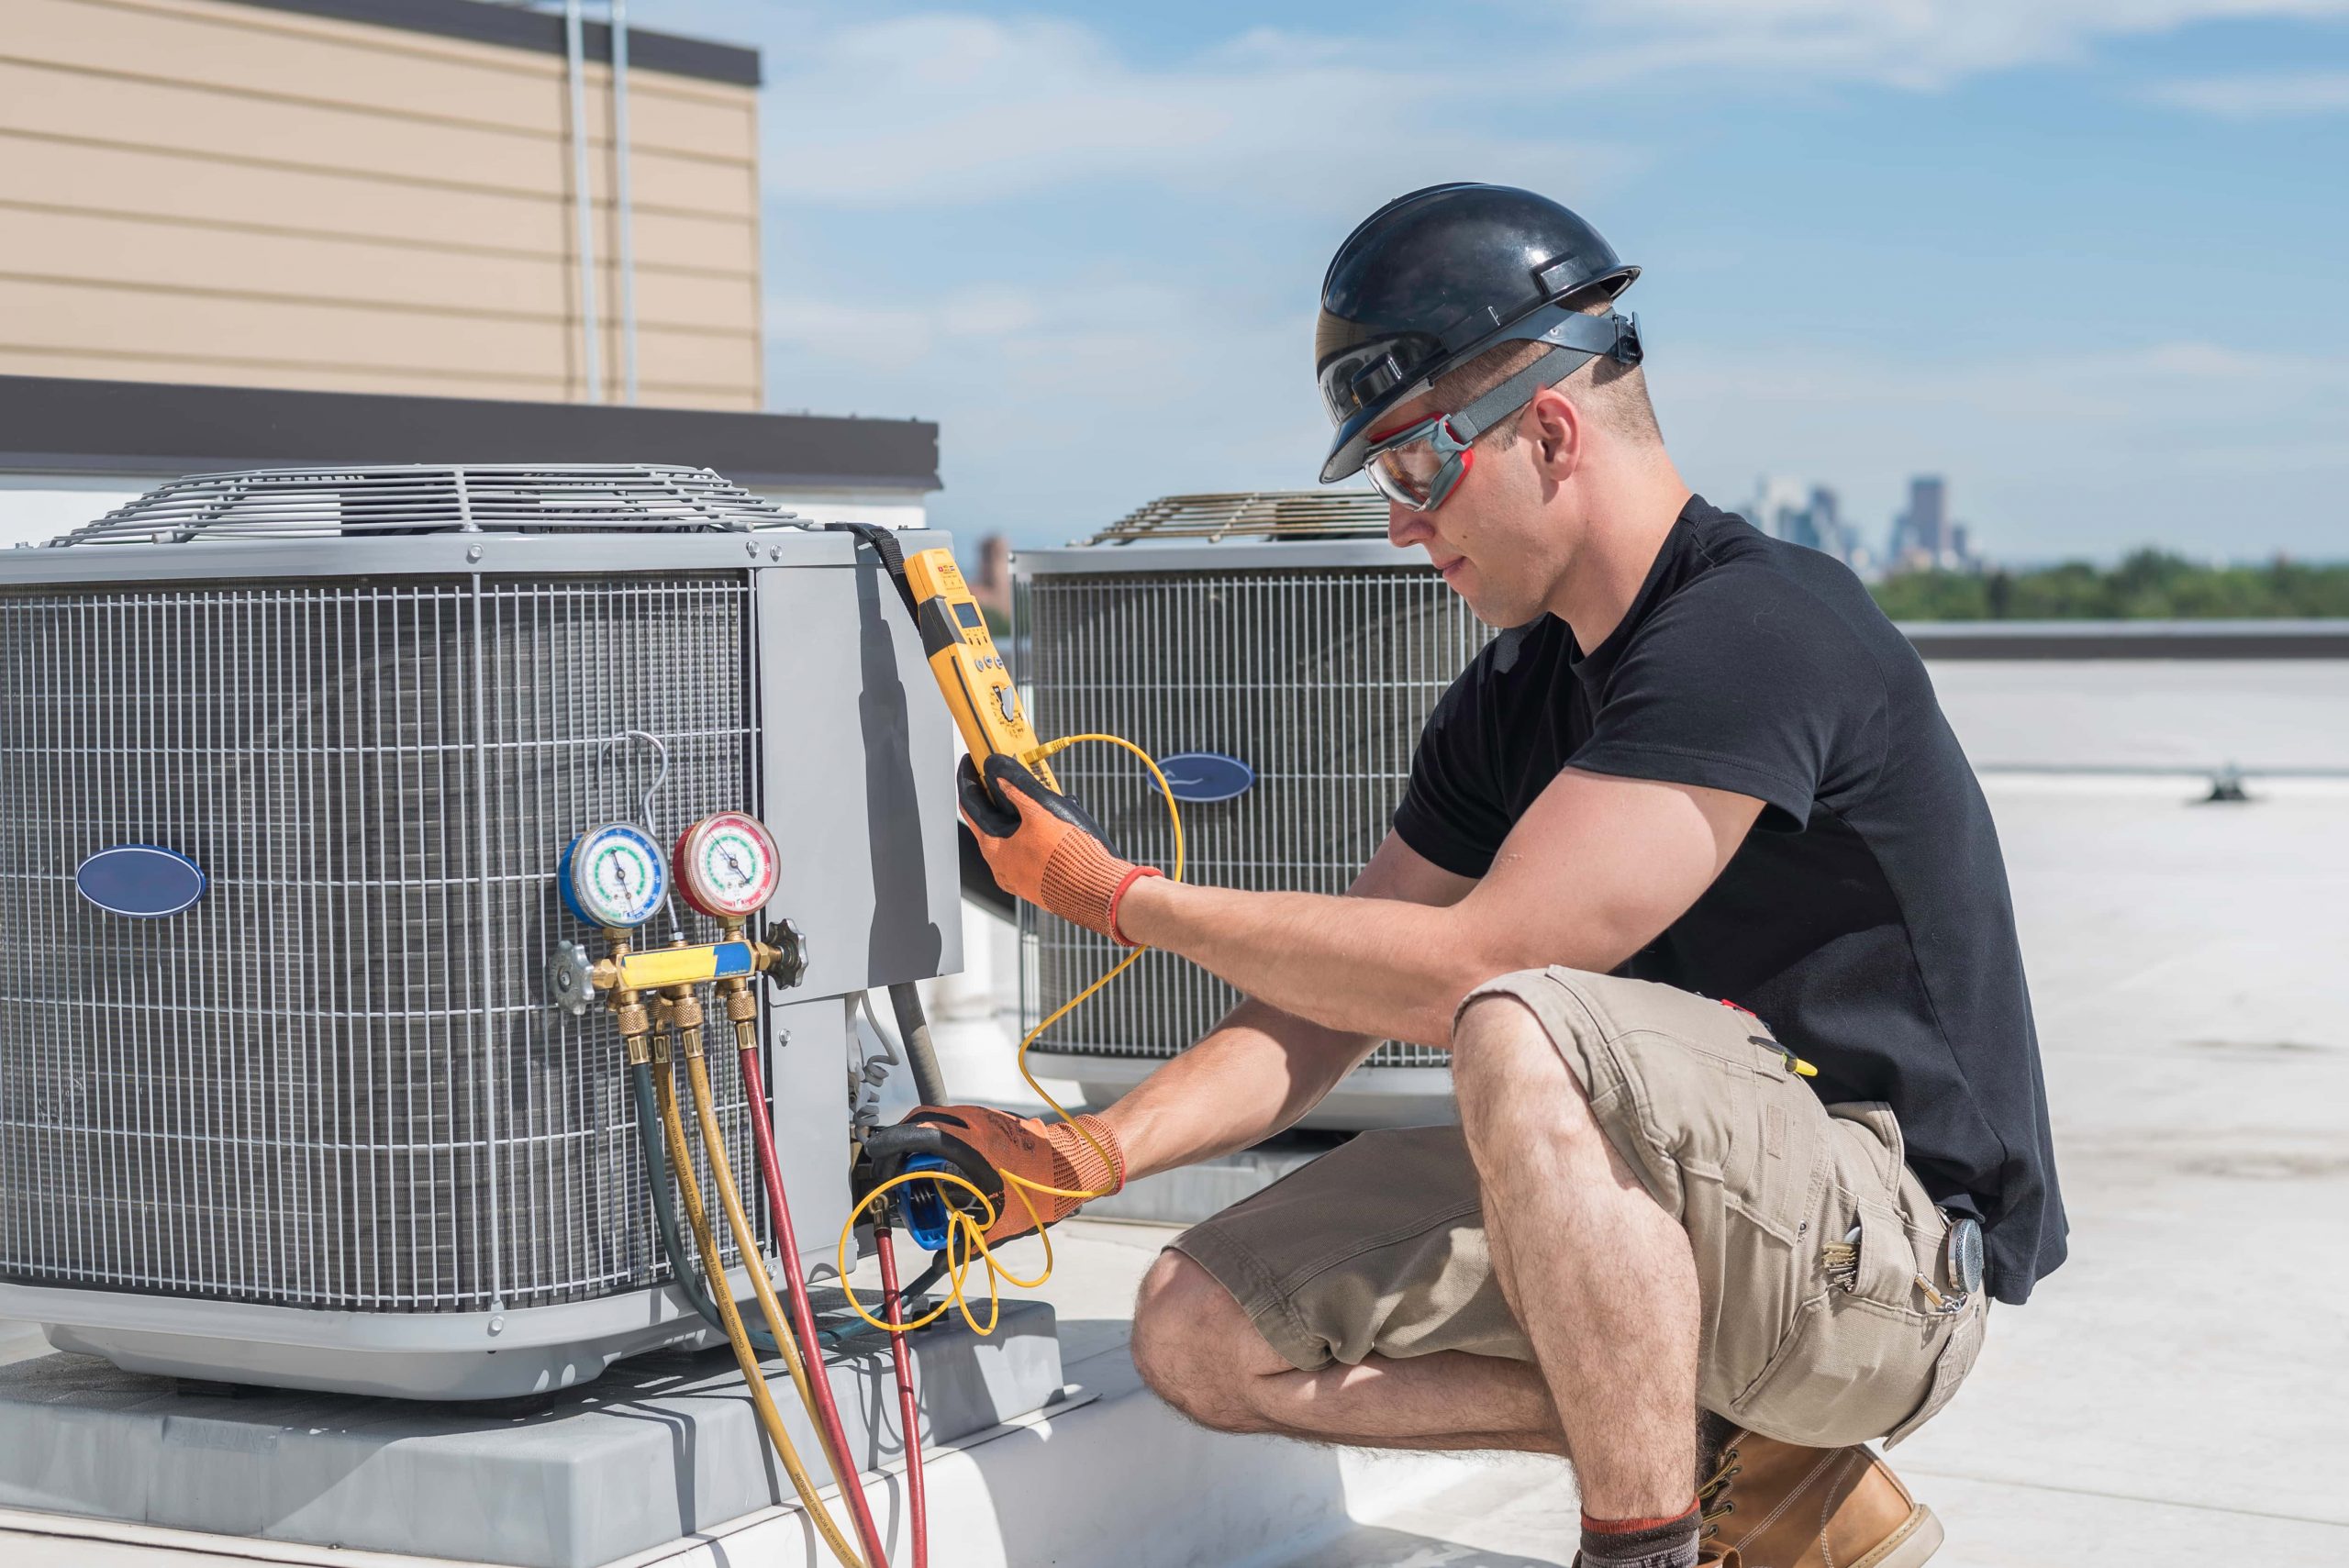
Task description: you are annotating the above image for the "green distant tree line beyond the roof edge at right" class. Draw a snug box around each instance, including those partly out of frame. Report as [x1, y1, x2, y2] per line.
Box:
[1875, 550, 2349, 619]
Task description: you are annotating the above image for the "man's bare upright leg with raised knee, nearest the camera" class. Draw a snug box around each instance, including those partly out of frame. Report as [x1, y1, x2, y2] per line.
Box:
[1452, 995, 1700, 1518]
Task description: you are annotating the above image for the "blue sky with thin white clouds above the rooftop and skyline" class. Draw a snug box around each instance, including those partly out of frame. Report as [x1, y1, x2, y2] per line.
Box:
[648, 0, 2349, 561]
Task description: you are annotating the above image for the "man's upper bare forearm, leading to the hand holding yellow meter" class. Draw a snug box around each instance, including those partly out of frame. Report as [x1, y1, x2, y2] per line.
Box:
[1119, 878, 1578, 1047]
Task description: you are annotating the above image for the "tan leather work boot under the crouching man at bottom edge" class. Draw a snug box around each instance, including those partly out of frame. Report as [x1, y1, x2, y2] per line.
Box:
[1698, 1432, 1941, 1568]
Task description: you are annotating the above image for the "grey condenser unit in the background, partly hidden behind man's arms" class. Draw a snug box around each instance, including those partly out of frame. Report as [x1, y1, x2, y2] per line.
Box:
[1012, 491, 1489, 1129]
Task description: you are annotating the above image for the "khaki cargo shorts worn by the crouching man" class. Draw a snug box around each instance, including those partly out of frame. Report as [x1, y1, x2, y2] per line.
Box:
[1174, 970, 1987, 1449]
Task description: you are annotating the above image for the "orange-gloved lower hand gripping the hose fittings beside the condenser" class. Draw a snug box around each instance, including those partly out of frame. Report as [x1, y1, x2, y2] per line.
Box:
[864, 1106, 1125, 1247]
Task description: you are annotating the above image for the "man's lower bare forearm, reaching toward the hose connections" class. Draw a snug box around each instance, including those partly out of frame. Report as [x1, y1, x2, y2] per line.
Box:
[1102, 1002, 1376, 1181]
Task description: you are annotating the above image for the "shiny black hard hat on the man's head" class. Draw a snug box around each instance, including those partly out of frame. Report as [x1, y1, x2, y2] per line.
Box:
[1313, 183, 1640, 484]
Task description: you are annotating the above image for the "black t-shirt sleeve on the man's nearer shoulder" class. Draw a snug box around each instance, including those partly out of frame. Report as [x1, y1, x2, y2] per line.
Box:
[1567, 571, 1884, 833]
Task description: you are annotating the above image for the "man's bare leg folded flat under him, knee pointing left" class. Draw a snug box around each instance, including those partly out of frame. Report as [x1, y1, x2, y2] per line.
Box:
[1134, 1251, 1564, 1455]
